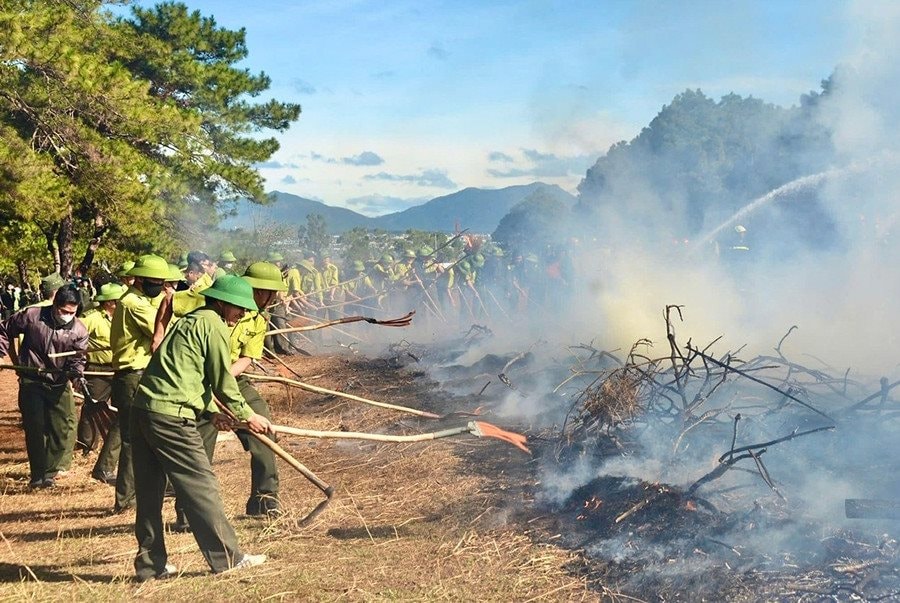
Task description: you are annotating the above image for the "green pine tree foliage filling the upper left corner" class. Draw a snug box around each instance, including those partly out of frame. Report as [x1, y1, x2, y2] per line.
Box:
[0, 0, 300, 284]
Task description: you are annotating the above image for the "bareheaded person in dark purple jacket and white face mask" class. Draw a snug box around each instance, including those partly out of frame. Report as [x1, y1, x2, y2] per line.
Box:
[0, 287, 88, 488]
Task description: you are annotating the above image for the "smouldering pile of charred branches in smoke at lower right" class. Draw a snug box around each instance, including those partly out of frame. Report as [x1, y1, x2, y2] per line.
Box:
[541, 306, 900, 601]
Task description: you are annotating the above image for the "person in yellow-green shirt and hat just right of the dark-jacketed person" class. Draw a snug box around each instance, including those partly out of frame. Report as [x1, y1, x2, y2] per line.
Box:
[78, 283, 126, 484]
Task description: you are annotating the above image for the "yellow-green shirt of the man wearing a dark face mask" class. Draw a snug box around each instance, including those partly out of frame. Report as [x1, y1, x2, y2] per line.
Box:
[109, 287, 164, 371]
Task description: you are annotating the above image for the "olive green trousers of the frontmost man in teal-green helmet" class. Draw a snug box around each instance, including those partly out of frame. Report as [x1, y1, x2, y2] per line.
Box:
[130, 408, 243, 580]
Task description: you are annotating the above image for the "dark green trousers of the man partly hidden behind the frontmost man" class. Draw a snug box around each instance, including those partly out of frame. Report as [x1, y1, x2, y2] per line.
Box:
[194, 377, 278, 513]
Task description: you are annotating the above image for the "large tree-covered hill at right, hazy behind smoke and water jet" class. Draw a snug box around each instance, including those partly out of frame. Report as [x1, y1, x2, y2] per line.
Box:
[576, 80, 833, 236]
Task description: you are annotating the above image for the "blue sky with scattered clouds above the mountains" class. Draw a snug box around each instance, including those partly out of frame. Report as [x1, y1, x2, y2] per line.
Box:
[130, 0, 865, 215]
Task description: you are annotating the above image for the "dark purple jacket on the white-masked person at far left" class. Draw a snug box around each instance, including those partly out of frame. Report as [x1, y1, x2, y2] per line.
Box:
[0, 306, 88, 385]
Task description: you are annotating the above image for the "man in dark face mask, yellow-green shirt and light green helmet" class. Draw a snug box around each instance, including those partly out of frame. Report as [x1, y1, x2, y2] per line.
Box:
[109, 255, 169, 513]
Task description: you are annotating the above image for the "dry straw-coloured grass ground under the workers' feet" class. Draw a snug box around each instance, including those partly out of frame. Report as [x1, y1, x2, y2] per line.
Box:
[0, 357, 597, 601]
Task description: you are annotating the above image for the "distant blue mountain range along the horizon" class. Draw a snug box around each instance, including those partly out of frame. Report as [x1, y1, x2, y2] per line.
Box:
[221, 182, 575, 234]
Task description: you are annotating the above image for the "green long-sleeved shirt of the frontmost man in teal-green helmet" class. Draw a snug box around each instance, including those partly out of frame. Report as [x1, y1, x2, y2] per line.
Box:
[134, 308, 253, 420]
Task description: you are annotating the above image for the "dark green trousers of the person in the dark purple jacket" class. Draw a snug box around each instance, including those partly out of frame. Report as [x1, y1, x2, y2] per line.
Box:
[19, 377, 75, 482]
